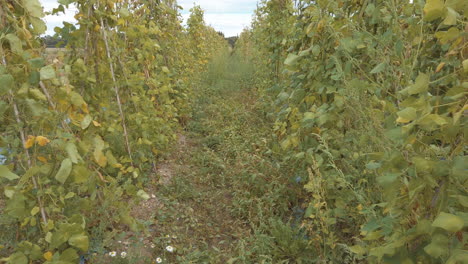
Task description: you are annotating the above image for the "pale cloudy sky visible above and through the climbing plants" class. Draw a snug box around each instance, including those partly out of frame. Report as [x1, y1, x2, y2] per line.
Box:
[40, 0, 258, 37]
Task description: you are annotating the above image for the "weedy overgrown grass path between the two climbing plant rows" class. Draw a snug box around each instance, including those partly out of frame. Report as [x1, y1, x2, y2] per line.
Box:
[93, 54, 301, 263]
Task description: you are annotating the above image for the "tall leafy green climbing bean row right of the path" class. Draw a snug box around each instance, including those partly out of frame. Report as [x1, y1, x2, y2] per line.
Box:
[243, 0, 468, 263]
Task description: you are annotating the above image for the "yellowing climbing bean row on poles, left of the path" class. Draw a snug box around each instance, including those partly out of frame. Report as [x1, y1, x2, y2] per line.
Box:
[0, 0, 227, 264]
